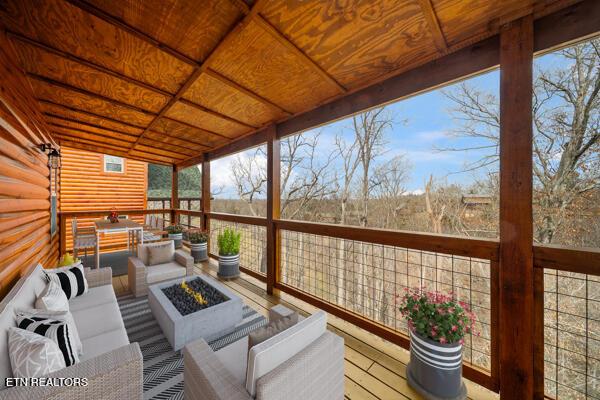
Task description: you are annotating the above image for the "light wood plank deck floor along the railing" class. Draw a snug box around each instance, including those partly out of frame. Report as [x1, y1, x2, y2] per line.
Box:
[113, 264, 498, 400]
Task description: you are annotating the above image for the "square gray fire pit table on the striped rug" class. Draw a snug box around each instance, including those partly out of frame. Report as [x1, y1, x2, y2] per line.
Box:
[148, 275, 243, 350]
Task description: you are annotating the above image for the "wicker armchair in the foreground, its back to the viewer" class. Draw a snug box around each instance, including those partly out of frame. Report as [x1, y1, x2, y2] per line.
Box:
[183, 305, 344, 400]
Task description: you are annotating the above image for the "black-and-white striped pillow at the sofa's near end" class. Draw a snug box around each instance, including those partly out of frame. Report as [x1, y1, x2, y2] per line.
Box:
[17, 315, 79, 367]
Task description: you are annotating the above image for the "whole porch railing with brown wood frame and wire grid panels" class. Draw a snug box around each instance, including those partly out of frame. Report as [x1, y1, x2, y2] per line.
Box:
[60, 206, 600, 399]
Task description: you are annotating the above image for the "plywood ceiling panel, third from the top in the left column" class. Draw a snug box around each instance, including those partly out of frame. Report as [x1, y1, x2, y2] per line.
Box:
[15, 38, 169, 112]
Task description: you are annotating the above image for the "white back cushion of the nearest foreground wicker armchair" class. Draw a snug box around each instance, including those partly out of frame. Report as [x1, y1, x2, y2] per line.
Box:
[246, 310, 327, 397]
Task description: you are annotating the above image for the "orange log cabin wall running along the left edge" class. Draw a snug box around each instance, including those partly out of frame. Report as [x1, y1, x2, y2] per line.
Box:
[0, 29, 60, 298]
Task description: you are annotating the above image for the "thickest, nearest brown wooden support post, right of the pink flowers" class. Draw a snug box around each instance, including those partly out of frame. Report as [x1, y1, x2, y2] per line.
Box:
[499, 15, 543, 400]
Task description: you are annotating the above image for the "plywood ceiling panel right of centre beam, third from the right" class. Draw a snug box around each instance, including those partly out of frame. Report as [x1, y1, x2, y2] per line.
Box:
[210, 19, 339, 113]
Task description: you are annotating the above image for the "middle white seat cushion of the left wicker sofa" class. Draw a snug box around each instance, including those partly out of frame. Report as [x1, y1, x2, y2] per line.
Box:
[71, 300, 124, 340]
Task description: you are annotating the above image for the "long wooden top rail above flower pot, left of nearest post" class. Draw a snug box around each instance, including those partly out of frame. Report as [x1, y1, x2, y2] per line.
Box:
[275, 220, 499, 261]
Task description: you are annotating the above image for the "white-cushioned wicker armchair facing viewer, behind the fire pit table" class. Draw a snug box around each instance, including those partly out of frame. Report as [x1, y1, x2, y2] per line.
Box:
[128, 240, 194, 297]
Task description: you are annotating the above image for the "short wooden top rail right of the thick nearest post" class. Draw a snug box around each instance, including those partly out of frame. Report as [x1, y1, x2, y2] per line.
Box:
[533, 245, 600, 275]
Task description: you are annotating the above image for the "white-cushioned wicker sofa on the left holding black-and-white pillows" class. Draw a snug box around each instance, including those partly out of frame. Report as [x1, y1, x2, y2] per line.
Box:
[0, 265, 143, 400]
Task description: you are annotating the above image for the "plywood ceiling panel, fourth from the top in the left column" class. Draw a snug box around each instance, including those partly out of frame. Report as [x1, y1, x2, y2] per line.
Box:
[31, 80, 152, 126]
